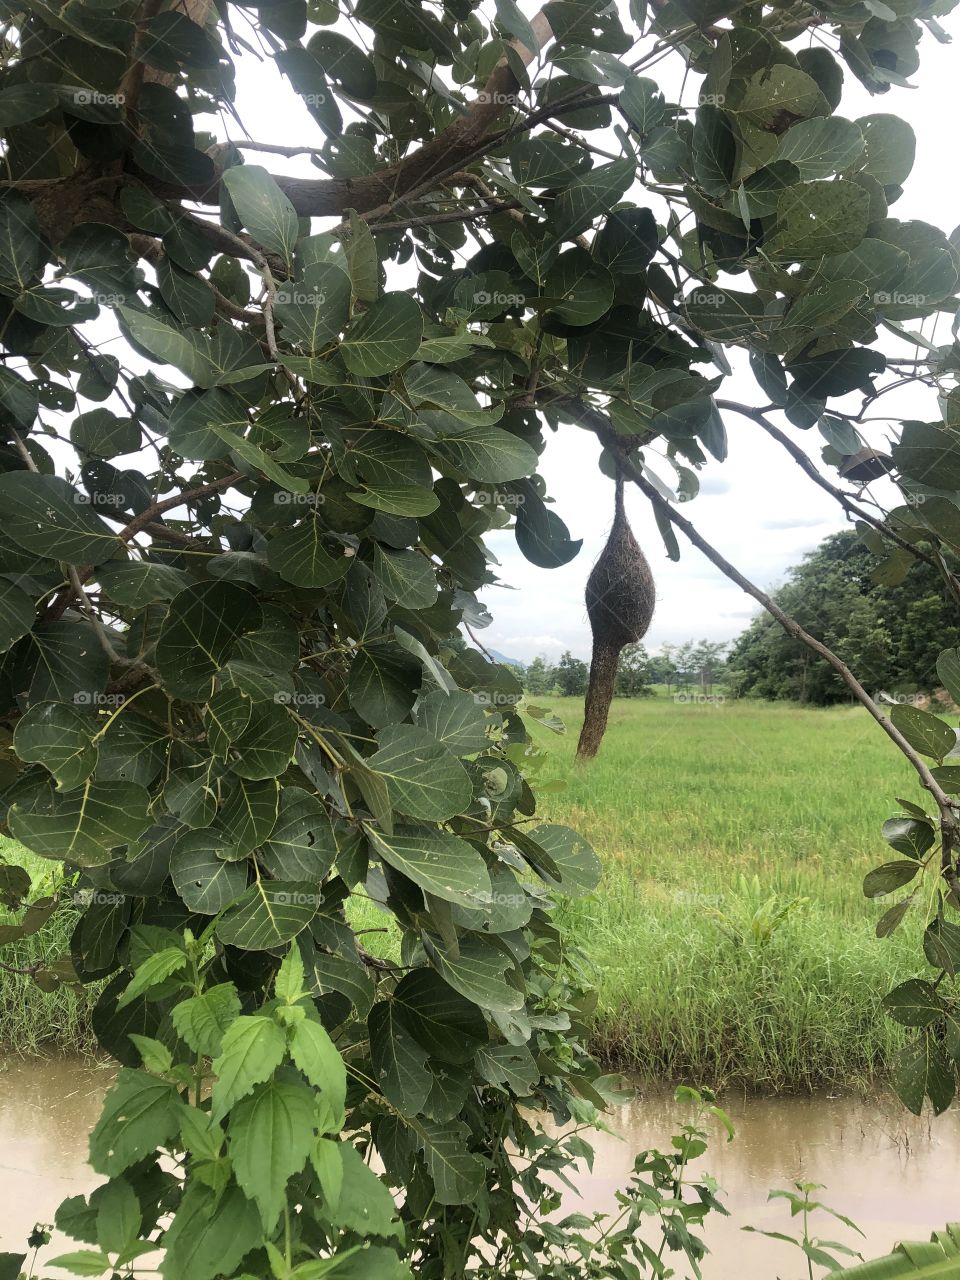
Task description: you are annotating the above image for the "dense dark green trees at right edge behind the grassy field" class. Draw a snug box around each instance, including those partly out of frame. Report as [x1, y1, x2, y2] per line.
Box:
[726, 530, 960, 707]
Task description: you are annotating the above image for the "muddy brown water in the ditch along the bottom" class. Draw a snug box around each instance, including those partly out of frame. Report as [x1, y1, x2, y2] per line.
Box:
[0, 1060, 960, 1280]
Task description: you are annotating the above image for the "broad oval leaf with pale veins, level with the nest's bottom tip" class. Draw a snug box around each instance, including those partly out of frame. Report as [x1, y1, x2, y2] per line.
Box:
[367, 724, 472, 822]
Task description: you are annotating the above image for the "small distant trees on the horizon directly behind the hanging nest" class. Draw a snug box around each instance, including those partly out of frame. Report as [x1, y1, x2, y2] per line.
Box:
[521, 640, 727, 698]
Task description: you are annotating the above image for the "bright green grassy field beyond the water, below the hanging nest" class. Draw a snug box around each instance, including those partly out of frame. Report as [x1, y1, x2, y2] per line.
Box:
[538, 698, 923, 1091]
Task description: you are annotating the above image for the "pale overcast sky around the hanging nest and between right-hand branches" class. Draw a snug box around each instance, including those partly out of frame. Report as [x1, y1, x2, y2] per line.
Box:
[213, 10, 960, 662]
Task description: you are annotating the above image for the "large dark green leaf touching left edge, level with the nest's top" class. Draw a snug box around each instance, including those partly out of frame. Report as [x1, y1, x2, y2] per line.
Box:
[0, 471, 123, 564]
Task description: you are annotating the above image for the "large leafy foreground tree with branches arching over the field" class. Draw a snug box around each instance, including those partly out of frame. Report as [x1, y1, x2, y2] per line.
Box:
[0, 0, 960, 1280]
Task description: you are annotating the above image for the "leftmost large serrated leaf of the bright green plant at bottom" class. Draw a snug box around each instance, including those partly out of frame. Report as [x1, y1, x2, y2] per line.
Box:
[90, 1066, 180, 1178]
